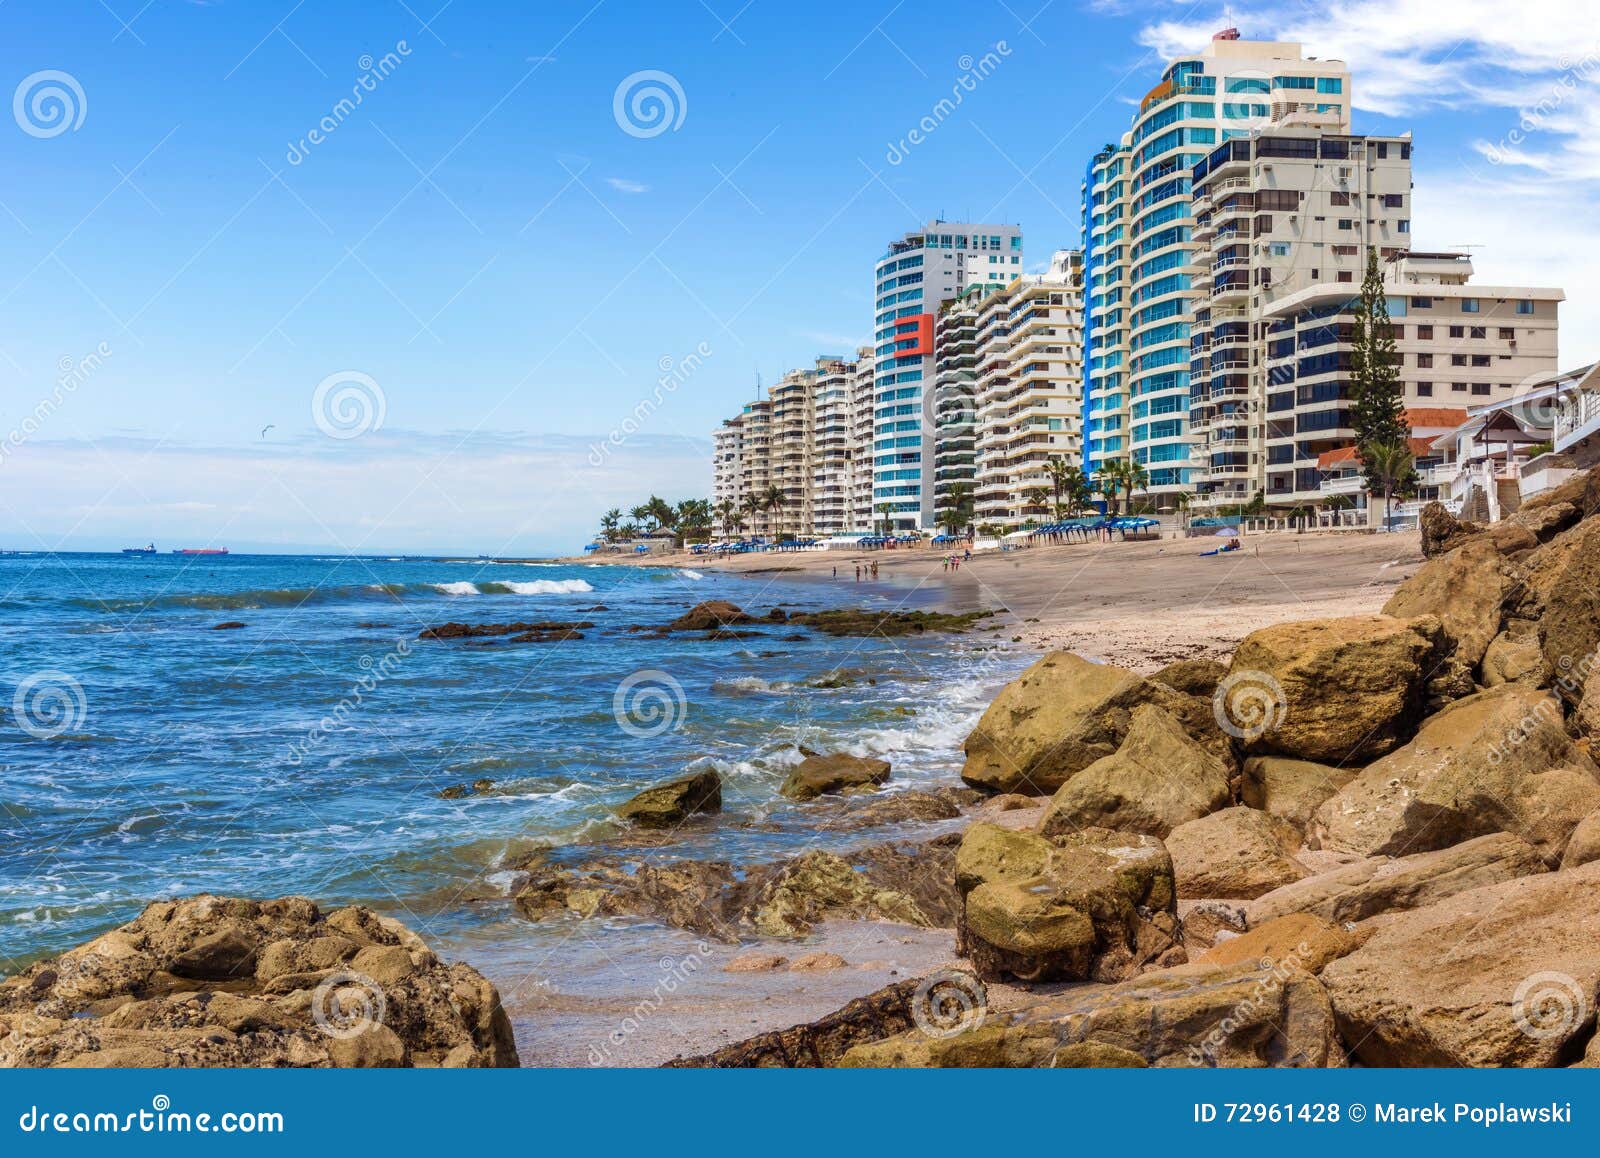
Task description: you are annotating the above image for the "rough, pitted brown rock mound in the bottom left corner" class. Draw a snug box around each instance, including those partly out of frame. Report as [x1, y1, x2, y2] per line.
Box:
[0, 896, 517, 1067]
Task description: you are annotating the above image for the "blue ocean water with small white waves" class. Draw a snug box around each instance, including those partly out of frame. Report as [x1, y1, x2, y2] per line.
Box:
[0, 555, 1026, 974]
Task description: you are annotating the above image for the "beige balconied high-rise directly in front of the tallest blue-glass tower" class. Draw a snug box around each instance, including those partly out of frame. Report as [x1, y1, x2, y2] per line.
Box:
[1190, 125, 1411, 509]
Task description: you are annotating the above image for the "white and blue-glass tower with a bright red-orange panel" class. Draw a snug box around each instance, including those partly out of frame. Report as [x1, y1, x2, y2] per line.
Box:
[872, 221, 1022, 529]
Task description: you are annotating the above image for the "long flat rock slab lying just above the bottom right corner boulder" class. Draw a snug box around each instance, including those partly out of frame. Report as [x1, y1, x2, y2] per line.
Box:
[1245, 832, 1547, 928]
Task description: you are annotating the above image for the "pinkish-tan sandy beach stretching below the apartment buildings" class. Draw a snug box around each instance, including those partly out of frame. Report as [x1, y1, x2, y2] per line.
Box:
[571, 533, 1422, 672]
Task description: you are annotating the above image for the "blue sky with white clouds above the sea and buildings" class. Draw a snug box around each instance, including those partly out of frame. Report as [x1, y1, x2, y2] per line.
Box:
[0, 0, 1600, 552]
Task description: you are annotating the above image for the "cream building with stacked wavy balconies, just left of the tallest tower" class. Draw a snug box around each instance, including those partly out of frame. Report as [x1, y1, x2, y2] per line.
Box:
[973, 250, 1083, 529]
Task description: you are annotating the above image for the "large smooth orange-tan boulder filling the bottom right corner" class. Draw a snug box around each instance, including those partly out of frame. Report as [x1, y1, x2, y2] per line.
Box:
[1322, 864, 1600, 1067]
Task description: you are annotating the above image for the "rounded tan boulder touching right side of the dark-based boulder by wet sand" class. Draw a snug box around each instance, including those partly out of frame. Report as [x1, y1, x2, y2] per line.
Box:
[1166, 806, 1309, 900]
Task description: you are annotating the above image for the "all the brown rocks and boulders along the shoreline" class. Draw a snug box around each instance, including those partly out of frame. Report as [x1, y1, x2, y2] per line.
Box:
[12, 472, 1600, 1067]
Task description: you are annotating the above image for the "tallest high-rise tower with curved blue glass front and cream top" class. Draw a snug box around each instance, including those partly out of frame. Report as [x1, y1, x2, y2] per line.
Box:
[1083, 29, 1350, 494]
